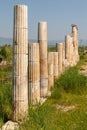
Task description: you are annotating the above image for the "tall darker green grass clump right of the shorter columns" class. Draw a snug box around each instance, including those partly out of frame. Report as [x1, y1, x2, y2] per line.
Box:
[54, 67, 87, 95]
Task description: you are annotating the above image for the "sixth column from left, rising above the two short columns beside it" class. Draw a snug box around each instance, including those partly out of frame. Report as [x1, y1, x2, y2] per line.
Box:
[56, 43, 63, 75]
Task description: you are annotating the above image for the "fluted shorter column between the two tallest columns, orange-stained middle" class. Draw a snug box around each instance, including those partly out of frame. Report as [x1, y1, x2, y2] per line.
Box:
[29, 43, 40, 104]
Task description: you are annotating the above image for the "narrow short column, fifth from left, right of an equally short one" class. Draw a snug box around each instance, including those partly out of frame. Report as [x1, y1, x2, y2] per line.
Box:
[54, 52, 58, 80]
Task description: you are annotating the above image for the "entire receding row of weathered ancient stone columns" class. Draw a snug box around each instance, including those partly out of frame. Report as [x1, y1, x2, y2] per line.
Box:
[13, 5, 79, 121]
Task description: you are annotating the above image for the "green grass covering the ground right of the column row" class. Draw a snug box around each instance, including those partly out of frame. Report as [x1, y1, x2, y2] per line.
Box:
[20, 64, 87, 130]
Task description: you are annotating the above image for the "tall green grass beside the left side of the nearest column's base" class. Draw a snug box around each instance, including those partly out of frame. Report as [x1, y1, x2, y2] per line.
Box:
[0, 82, 12, 122]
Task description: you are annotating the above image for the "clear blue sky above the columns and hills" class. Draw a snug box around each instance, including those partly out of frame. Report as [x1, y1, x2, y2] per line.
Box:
[0, 0, 87, 40]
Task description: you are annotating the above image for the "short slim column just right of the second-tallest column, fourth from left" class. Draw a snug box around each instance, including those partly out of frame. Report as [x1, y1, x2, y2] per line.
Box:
[48, 52, 54, 91]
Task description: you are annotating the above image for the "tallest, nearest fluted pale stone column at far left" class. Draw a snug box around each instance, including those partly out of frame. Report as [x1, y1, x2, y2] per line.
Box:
[13, 5, 28, 121]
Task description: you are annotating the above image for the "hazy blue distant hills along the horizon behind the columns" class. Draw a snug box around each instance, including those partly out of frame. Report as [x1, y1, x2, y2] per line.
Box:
[0, 37, 87, 46]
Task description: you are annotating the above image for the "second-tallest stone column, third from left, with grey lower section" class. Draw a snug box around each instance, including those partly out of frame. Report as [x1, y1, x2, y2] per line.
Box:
[38, 22, 48, 97]
